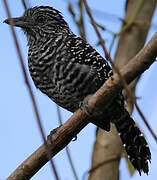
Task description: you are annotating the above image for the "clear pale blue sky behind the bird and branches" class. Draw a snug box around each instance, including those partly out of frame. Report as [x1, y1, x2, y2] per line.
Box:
[0, 0, 157, 180]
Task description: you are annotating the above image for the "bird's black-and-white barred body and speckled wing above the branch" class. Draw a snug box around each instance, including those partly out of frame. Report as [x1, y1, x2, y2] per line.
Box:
[29, 35, 112, 112]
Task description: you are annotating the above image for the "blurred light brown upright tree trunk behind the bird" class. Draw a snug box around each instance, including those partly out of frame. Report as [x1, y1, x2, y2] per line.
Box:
[89, 0, 156, 180]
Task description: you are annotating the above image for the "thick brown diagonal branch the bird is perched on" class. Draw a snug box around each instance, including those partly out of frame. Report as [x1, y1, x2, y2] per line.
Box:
[8, 28, 157, 180]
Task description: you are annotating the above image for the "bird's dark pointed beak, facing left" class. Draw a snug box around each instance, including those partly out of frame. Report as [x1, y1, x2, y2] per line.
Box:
[4, 17, 30, 28]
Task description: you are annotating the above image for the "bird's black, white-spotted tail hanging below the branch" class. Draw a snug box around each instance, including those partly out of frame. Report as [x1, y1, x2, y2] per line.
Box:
[114, 109, 151, 175]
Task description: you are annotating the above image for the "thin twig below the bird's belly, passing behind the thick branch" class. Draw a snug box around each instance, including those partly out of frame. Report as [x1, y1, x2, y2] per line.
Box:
[56, 105, 79, 180]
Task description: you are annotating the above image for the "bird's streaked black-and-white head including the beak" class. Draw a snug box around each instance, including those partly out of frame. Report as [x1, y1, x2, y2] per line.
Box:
[4, 6, 69, 42]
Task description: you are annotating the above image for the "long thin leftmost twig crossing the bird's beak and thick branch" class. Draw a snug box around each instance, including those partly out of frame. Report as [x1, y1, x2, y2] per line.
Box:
[3, 0, 59, 180]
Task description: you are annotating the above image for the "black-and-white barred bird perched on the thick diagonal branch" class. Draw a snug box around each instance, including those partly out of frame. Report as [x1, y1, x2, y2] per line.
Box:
[4, 6, 151, 175]
